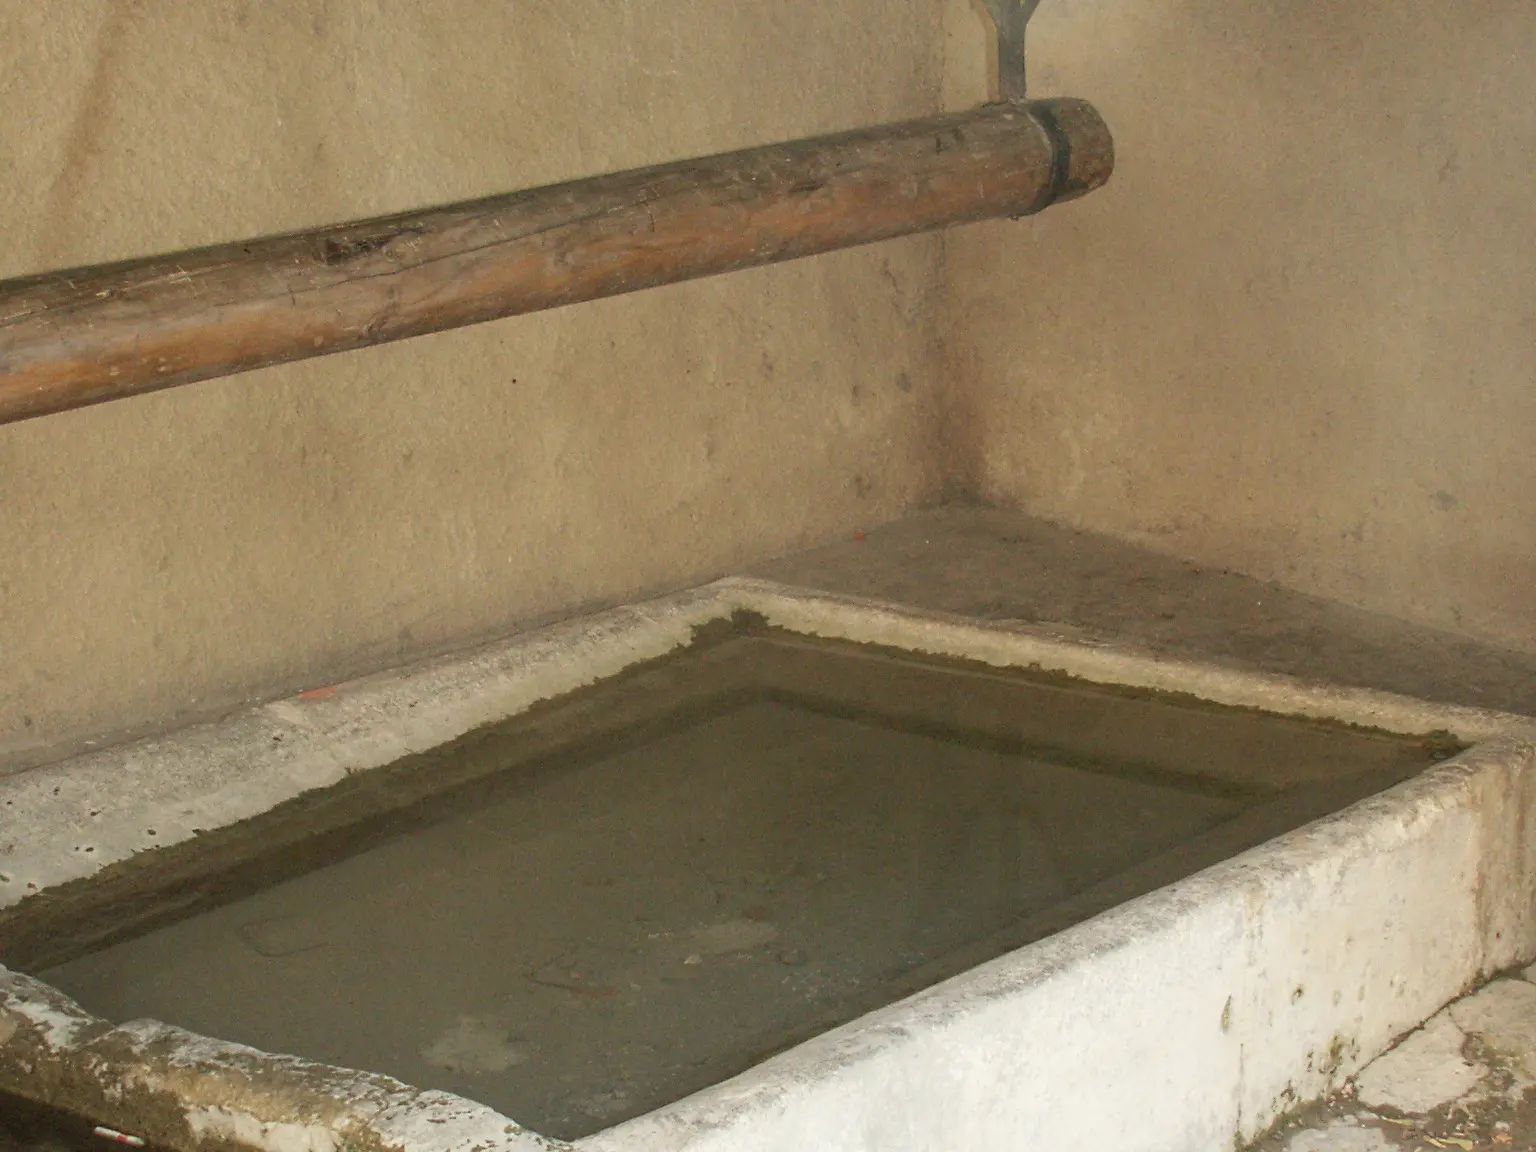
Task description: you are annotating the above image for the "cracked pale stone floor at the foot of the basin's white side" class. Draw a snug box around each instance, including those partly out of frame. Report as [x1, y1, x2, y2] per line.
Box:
[1252, 968, 1536, 1152]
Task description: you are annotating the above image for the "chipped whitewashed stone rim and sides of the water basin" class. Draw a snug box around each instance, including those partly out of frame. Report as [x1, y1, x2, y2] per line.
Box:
[0, 579, 1536, 1152]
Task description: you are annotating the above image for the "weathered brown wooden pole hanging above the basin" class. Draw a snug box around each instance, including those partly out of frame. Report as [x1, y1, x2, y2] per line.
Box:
[0, 100, 1114, 424]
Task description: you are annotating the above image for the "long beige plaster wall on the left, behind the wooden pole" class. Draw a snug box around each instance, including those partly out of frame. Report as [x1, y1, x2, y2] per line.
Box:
[0, 0, 943, 766]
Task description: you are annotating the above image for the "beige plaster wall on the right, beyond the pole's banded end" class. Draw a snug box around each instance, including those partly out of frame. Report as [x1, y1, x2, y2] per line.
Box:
[946, 0, 1536, 647]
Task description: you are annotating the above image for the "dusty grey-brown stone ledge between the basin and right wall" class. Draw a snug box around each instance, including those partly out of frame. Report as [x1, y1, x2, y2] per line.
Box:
[751, 505, 1536, 716]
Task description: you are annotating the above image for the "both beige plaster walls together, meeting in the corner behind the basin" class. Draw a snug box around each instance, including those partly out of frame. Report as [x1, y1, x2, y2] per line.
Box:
[9, 0, 1536, 766]
